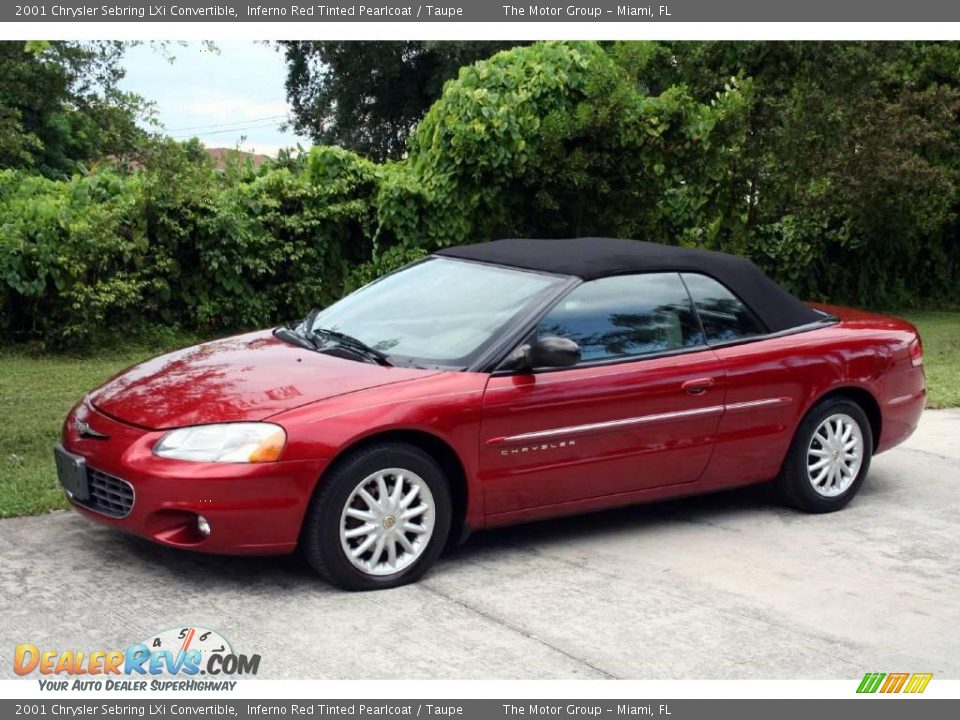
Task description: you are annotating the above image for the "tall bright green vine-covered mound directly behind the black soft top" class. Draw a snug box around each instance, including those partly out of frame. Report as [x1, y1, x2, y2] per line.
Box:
[377, 42, 744, 256]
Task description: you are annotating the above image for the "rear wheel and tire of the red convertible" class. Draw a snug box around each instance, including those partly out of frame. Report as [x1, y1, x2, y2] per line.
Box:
[776, 398, 873, 513]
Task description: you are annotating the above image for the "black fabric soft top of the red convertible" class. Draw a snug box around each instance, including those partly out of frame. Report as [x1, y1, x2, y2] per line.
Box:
[435, 238, 824, 332]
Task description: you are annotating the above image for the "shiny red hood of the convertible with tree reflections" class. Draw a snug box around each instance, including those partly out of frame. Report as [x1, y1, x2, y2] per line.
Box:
[89, 330, 436, 430]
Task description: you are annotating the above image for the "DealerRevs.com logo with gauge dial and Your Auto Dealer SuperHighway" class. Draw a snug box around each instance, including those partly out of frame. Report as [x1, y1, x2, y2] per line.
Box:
[13, 627, 260, 691]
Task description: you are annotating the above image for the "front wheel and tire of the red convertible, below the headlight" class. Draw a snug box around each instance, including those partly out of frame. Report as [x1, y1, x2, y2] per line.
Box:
[300, 443, 452, 590]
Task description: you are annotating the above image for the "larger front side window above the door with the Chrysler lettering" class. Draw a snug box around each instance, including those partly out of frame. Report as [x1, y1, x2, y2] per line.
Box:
[537, 273, 703, 361]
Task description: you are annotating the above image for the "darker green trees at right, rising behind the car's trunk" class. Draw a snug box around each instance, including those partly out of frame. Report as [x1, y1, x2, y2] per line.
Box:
[636, 41, 960, 305]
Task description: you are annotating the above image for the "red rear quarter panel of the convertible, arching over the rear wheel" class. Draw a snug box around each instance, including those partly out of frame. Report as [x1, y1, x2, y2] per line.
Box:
[704, 306, 924, 487]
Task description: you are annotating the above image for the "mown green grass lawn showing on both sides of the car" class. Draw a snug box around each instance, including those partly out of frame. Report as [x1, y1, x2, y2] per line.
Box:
[0, 312, 960, 517]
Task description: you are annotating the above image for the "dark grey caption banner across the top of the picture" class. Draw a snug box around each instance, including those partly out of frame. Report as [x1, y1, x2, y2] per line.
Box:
[7, 0, 960, 23]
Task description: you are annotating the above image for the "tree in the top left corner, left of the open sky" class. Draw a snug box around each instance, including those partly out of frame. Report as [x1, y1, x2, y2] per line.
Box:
[0, 42, 147, 177]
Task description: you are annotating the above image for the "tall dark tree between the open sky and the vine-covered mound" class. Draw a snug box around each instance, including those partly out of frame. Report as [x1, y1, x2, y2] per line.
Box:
[279, 40, 517, 160]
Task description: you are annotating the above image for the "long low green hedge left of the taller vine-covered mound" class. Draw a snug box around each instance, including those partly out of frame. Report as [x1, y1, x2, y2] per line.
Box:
[0, 143, 379, 347]
